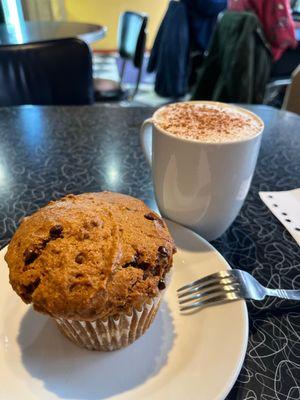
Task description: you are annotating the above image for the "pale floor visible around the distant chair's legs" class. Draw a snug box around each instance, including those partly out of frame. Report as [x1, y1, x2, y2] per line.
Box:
[93, 53, 177, 107]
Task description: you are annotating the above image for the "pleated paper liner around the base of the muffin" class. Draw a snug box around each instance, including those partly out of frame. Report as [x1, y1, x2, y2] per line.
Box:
[55, 294, 162, 351]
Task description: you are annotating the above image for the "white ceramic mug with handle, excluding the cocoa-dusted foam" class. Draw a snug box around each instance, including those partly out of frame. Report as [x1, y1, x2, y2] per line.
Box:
[140, 101, 264, 240]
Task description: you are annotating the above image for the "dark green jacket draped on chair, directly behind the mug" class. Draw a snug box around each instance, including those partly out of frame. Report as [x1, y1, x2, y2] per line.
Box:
[192, 11, 271, 103]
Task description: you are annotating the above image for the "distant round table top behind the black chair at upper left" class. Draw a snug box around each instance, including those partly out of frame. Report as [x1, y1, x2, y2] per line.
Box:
[0, 21, 106, 46]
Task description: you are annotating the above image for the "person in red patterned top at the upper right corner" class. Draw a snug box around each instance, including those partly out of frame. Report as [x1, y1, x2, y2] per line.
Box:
[228, 0, 300, 77]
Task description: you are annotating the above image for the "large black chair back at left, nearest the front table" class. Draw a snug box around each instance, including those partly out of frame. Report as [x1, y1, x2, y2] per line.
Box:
[0, 38, 94, 106]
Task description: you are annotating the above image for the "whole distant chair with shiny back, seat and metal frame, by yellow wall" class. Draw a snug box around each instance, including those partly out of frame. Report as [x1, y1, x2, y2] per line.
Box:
[94, 11, 148, 101]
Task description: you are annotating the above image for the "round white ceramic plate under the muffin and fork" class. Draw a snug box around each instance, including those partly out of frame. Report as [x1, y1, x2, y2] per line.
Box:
[0, 223, 248, 400]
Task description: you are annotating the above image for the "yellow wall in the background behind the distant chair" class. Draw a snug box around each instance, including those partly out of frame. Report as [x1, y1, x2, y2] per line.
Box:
[65, 0, 169, 50]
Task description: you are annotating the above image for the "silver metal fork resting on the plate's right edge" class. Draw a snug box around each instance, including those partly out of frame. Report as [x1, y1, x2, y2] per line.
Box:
[177, 269, 300, 311]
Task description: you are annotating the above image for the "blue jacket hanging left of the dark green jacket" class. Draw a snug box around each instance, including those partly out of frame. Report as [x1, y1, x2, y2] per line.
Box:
[147, 1, 189, 98]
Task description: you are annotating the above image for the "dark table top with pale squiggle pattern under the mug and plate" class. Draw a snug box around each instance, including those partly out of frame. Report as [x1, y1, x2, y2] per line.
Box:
[0, 106, 300, 400]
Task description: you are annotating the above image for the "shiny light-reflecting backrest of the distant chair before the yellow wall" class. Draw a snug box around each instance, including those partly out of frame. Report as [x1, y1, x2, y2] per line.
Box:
[118, 11, 148, 68]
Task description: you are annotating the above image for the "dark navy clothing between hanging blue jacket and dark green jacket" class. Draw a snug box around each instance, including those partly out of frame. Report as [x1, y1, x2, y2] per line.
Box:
[181, 0, 227, 52]
